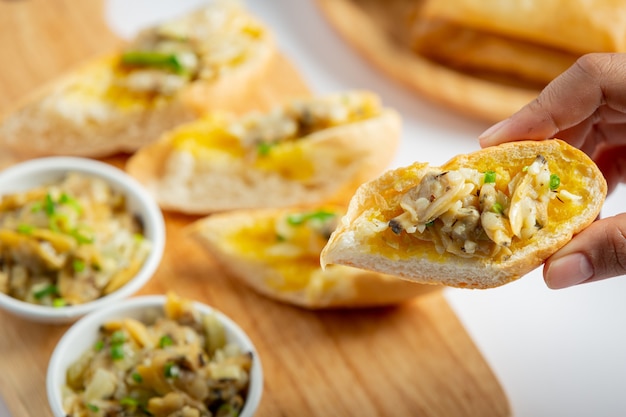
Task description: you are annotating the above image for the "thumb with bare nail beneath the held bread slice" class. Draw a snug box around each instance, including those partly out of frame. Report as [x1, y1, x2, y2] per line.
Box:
[543, 213, 626, 289]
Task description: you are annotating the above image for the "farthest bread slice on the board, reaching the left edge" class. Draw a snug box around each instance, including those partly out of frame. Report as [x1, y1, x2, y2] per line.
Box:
[0, 1, 288, 159]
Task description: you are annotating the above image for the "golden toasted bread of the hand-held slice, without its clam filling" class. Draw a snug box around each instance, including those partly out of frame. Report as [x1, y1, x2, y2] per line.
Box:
[321, 139, 607, 288]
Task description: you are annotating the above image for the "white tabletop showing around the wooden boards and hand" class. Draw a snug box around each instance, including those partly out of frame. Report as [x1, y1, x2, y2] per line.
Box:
[106, 0, 626, 417]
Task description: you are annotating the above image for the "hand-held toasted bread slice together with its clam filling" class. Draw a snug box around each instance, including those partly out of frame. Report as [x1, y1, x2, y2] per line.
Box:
[321, 139, 607, 288]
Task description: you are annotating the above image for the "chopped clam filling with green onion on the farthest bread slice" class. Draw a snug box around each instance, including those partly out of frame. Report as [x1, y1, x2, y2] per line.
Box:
[117, 2, 268, 95]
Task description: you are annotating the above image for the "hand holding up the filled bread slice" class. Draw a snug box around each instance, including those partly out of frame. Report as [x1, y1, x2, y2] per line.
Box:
[479, 53, 626, 289]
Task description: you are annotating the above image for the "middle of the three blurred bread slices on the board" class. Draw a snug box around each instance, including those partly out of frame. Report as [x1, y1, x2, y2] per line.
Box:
[126, 91, 401, 214]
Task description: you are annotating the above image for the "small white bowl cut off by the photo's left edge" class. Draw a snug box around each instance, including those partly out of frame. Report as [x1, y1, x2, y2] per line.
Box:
[0, 157, 165, 323]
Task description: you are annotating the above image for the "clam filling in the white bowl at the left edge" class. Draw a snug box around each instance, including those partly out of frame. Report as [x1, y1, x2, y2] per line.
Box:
[0, 172, 151, 307]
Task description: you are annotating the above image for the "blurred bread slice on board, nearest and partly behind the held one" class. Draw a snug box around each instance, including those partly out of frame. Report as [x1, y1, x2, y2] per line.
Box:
[188, 207, 439, 309]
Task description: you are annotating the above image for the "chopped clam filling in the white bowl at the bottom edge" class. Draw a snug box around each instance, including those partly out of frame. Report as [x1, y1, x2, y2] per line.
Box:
[63, 294, 252, 417]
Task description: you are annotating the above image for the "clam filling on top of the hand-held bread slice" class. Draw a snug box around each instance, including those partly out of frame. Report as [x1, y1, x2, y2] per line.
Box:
[387, 155, 582, 258]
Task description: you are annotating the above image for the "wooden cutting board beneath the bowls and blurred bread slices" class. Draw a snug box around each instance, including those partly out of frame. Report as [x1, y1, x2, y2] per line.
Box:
[0, 0, 511, 417]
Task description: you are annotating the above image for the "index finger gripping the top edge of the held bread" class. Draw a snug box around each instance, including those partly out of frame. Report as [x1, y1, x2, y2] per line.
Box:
[479, 54, 626, 147]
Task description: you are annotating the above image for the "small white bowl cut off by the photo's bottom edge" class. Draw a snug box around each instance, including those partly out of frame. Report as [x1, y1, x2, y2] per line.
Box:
[46, 295, 263, 417]
